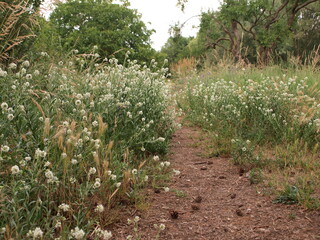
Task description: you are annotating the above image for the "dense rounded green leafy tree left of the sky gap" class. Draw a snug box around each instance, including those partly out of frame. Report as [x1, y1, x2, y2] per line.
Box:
[50, 0, 154, 61]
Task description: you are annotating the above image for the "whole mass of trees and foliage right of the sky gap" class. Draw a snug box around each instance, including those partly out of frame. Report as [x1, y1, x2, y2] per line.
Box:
[191, 0, 320, 64]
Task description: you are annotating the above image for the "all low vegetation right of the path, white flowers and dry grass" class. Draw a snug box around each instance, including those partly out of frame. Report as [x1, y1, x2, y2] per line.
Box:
[179, 67, 320, 208]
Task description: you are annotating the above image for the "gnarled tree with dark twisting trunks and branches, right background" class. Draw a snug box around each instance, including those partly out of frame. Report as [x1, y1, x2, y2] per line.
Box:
[220, 0, 318, 64]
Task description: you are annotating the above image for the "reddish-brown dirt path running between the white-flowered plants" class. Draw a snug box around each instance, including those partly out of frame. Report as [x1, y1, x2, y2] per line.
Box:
[115, 123, 320, 240]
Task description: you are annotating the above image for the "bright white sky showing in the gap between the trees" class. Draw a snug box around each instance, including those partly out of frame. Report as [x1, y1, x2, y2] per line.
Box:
[41, 0, 220, 50]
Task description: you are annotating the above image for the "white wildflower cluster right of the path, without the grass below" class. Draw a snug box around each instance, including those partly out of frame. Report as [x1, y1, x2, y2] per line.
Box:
[185, 75, 320, 142]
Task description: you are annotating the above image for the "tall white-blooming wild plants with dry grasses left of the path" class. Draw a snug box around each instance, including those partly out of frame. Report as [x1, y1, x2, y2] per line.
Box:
[0, 54, 175, 239]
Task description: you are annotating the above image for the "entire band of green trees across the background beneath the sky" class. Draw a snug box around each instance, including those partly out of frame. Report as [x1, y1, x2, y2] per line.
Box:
[0, 0, 320, 66]
